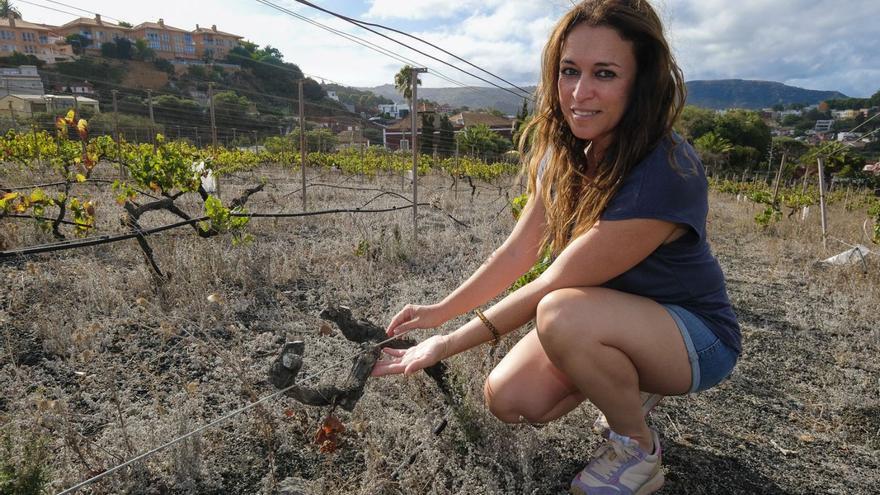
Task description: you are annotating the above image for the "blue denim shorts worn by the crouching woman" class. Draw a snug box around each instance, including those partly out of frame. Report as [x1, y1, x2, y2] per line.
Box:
[663, 304, 739, 394]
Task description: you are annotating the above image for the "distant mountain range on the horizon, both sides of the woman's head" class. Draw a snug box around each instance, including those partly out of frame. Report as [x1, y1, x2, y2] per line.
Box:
[362, 79, 847, 115]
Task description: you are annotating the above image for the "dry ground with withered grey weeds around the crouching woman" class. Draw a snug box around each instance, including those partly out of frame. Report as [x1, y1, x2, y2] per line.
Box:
[0, 171, 880, 495]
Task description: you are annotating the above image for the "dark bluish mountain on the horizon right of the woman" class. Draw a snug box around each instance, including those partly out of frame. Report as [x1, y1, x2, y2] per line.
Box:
[687, 79, 847, 109]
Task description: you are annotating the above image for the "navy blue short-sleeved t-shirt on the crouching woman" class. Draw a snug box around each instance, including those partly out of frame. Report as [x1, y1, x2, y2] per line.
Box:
[600, 135, 742, 352]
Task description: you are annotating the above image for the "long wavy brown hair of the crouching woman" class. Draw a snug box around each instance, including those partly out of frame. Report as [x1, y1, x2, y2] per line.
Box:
[519, 0, 686, 254]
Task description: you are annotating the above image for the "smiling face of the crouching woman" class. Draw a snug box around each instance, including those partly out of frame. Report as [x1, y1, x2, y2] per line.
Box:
[558, 24, 636, 156]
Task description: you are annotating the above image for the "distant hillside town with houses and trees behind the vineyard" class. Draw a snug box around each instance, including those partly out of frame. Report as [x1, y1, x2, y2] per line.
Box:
[0, 10, 880, 176]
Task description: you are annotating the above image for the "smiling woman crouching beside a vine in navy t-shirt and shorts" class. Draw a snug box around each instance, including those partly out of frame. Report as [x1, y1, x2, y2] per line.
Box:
[373, 0, 740, 494]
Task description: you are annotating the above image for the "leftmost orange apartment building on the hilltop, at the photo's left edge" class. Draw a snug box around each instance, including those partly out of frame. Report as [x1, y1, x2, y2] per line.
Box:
[0, 17, 73, 64]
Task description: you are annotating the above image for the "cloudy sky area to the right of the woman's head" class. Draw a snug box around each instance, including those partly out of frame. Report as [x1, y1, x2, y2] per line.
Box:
[665, 0, 880, 96]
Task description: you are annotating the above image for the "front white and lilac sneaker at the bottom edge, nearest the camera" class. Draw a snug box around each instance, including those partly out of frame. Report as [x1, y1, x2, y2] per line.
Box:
[571, 430, 663, 495]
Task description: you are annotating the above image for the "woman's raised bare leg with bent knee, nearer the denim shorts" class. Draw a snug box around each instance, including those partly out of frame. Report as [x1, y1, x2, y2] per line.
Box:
[537, 287, 691, 452]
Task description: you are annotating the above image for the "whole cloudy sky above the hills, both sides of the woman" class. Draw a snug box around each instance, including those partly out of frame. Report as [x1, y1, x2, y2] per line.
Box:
[11, 0, 880, 97]
